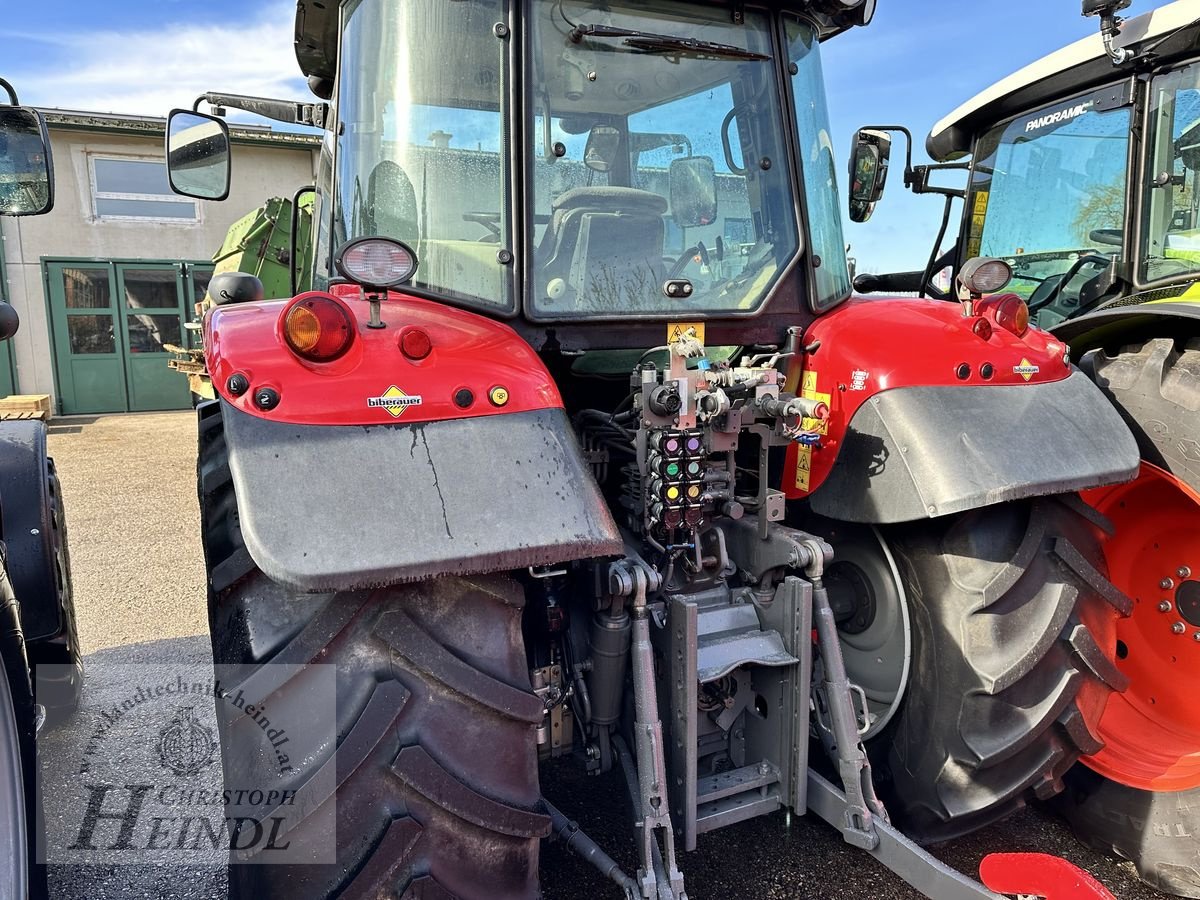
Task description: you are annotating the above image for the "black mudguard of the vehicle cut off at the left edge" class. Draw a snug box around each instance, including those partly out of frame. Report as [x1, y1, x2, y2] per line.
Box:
[0, 420, 62, 642]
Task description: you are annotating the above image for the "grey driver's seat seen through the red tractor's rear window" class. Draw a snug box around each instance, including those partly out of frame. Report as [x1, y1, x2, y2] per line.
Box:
[538, 187, 667, 310]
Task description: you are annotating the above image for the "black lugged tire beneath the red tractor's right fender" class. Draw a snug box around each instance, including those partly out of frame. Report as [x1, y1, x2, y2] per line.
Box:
[871, 498, 1128, 844]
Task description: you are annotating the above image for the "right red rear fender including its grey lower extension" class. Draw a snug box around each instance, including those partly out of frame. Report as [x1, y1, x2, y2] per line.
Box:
[782, 299, 1139, 524]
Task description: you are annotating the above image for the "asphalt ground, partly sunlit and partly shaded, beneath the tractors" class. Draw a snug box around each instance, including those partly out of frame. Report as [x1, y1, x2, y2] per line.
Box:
[40, 413, 1165, 900]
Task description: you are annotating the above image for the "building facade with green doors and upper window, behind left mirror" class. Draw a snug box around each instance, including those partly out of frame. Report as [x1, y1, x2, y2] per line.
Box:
[0, 109, 319, 415]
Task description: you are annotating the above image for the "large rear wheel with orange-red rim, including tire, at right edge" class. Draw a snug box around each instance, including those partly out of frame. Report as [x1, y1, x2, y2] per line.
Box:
[1058, 337, 1200, 898]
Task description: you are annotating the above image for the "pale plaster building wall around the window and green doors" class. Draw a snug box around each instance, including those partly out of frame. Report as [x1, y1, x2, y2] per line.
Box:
[0, 126, 317, 408]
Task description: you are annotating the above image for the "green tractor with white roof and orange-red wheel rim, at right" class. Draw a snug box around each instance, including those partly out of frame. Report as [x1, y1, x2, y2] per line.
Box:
[852, 0, 1200, 898]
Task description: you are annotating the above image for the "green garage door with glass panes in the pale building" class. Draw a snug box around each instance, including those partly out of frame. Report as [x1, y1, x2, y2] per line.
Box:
[46, 260, 212, 415]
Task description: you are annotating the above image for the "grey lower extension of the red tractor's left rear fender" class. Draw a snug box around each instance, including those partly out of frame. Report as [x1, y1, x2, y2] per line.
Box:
[221, 403, 623, 592]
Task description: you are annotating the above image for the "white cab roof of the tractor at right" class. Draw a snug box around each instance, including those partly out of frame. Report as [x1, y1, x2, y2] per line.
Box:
[925, 0, 1200, 162]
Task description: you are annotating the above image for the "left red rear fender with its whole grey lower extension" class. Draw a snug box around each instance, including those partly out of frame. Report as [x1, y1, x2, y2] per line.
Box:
[205, 286, 623, 592]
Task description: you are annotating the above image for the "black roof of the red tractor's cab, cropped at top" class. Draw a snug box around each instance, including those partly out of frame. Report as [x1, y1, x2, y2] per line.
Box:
[295, 0, 873, 90]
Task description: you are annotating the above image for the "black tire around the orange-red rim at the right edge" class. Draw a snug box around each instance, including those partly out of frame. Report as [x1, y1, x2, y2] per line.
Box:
[1056, 337, 1200, 898]
